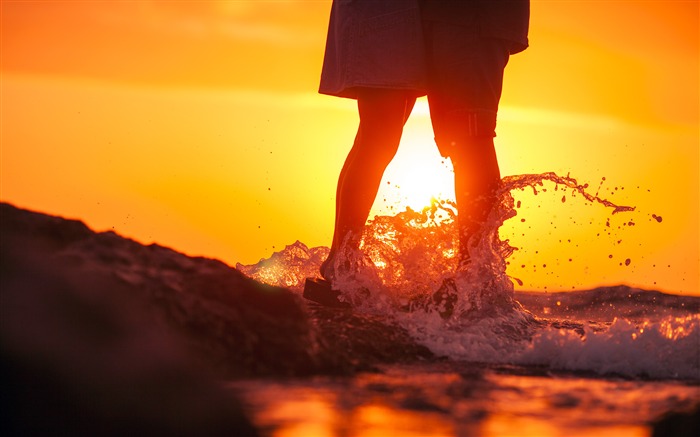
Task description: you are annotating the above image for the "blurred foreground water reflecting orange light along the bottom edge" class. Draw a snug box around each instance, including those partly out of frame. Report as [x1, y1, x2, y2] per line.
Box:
[229, 363, 700, 437]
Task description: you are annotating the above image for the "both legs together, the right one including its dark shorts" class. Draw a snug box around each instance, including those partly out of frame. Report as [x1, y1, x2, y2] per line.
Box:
[321, 26, 509, 280]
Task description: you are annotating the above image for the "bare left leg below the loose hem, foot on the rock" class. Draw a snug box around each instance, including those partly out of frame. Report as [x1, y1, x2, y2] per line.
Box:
[321, 89, 415, 280]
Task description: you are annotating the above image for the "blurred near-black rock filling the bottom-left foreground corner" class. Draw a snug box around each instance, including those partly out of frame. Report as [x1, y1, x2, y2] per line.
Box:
[0, 220, 257, 436]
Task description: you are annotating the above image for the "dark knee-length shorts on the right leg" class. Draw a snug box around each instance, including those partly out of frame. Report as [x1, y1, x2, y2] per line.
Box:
[423, 21, 511, 156]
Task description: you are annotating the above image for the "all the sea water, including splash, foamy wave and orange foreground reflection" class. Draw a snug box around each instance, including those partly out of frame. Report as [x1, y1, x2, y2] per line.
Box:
[236, 173, 700, 435]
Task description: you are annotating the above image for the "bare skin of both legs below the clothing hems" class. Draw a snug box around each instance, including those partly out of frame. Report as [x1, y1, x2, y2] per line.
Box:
[321, 93, 500, 280]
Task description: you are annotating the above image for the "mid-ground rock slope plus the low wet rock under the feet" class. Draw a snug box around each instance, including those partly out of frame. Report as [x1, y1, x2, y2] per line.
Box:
[0, 204, 432, 379]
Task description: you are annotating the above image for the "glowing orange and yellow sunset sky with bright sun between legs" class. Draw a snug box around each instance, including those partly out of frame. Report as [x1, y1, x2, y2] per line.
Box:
[0, 0, 700, 294]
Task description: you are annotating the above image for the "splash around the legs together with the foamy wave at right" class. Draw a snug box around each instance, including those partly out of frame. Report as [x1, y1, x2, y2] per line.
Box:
[237, 173, 700, 379]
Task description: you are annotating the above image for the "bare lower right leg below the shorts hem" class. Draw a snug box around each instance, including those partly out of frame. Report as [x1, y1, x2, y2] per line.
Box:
[451, 137, 501, 263]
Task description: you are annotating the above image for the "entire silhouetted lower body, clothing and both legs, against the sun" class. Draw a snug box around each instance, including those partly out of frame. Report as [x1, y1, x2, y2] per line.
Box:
[319, 0, 529, 282]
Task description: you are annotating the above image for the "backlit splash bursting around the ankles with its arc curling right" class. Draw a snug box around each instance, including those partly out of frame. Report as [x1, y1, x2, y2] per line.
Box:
[328, 173, 634, 321]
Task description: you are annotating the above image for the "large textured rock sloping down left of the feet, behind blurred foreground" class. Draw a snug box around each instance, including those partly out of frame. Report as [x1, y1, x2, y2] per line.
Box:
[0, 204, 317, 378]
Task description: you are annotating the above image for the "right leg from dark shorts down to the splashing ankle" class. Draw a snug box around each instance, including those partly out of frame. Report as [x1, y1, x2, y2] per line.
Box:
[426, 23, 509, 262]
